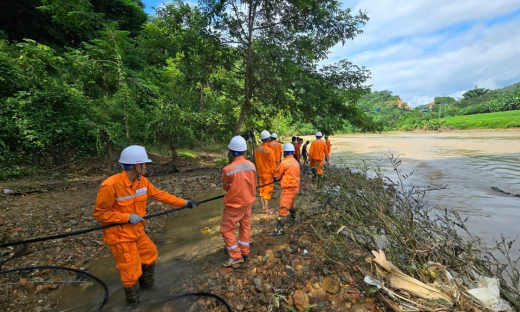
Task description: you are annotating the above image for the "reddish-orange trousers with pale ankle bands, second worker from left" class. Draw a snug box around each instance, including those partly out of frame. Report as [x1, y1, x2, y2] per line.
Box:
[220, 206, 252, 260]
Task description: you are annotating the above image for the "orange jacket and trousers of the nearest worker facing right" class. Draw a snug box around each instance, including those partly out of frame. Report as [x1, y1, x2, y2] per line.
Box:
[93, 171, 186, 288]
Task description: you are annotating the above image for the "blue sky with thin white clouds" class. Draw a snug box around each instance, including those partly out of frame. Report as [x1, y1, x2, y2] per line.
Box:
[144, 0, 520, 107]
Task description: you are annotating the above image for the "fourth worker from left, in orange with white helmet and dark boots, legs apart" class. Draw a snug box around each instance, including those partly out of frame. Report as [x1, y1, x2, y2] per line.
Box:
[271, 143, 300, 236]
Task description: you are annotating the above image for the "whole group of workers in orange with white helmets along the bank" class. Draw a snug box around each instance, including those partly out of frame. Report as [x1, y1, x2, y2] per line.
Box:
[93, 130, 330, 303]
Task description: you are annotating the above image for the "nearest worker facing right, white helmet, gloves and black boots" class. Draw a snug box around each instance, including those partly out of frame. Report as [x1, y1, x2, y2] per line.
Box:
[93, 145, 198, 303]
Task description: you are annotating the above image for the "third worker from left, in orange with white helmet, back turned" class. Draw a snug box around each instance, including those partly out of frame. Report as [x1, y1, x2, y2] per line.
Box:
[255, 130, 278, 214]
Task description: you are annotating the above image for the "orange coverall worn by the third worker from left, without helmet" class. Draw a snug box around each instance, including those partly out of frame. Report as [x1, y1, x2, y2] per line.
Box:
[255, 142, 278, 200]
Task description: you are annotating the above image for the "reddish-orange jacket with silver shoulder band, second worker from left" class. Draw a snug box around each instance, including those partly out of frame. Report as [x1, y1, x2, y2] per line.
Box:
[222, 156, 256, 210]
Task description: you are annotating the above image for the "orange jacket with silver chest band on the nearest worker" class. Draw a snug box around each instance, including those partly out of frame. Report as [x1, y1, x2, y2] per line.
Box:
[93, 171, 186, 244]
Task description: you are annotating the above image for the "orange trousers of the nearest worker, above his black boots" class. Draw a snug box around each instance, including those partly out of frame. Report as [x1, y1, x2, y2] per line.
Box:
[109, 233, 158, 288]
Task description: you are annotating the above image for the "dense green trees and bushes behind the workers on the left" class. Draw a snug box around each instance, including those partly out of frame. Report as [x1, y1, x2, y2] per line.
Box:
[0, 0, 380, 177]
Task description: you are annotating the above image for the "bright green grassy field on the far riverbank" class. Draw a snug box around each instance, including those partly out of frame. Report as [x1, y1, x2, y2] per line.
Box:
[444, 110, 520, 129]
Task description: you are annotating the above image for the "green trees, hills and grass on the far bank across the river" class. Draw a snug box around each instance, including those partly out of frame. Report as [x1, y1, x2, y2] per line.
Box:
[358, 82, 520, 131]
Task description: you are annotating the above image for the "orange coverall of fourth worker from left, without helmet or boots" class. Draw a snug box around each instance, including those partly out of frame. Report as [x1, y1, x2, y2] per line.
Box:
[278, 155, 300, 217]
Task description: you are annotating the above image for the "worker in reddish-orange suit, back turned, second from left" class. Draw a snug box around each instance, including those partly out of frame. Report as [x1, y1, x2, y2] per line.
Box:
[220, 136, 256, 267]
